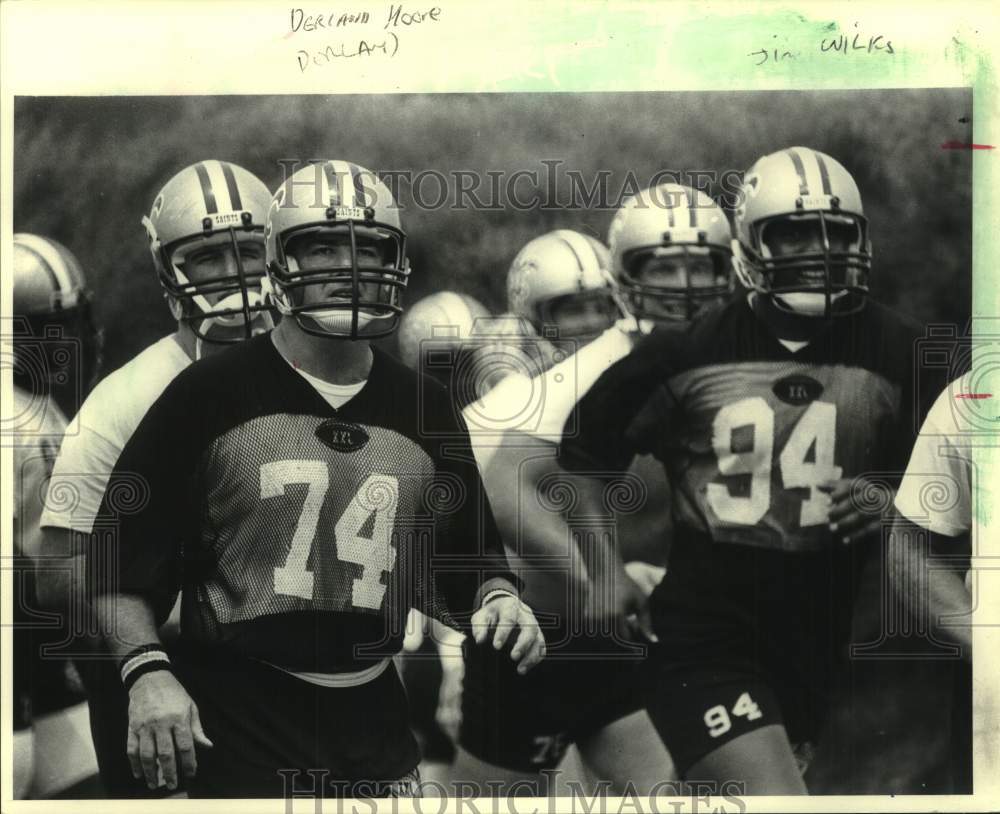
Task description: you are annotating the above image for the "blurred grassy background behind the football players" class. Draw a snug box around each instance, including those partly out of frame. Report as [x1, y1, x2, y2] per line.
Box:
[13, 89, 972, 794]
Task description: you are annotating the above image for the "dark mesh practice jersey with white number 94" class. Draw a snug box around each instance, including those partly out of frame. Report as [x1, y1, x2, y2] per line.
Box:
[562, 299, 932, 551]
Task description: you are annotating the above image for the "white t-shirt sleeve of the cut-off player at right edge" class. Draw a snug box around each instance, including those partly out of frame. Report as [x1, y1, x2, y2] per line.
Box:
[896, 386, 972, 537]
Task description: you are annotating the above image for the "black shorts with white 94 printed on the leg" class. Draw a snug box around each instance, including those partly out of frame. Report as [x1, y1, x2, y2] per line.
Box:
[643, 541, 867, 777]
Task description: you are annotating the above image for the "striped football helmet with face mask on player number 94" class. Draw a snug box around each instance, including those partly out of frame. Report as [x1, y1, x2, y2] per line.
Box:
[734, 147, 872, 317]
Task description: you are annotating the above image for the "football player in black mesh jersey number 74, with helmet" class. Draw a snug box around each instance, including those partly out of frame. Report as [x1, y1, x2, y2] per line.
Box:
[94, 161, 544, 799]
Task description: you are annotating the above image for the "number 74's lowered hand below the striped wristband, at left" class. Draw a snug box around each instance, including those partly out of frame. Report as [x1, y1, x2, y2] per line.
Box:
[126, 670, 212, 790]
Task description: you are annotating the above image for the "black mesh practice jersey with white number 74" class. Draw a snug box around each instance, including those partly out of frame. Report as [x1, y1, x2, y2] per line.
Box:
[95, 336, 515, 672]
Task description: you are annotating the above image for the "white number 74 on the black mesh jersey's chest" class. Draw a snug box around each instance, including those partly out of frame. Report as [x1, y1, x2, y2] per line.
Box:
[260, 460, 399, 610]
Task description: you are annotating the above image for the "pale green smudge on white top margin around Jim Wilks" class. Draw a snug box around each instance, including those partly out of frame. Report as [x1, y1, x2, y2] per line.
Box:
[489, 6, 974, 92]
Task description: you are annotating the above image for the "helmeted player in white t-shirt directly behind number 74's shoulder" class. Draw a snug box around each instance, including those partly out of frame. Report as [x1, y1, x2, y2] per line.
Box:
[40, 160, 273, 798]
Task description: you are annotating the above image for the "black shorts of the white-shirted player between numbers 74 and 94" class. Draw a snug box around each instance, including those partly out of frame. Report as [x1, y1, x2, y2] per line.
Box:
[459, 636, 642, 772]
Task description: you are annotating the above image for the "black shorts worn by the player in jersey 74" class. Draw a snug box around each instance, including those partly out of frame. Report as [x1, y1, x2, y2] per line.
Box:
[173, 648, 420, 798]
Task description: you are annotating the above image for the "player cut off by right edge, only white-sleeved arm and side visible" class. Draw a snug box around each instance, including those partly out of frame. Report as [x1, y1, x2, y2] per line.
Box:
[889, 371, 976, 794]
